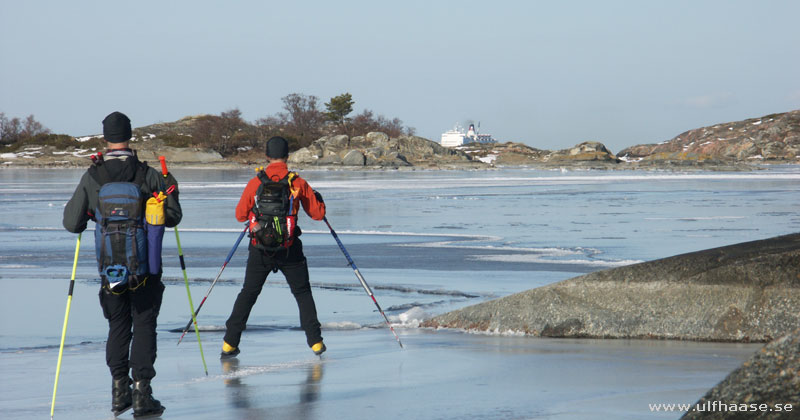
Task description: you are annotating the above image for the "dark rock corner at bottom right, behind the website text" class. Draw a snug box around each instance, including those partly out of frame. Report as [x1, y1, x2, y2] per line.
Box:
[681, 329, 800, 420]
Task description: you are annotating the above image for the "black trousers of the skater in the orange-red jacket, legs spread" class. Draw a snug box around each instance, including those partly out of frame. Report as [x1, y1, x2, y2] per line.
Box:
[225, 238, 322, 347]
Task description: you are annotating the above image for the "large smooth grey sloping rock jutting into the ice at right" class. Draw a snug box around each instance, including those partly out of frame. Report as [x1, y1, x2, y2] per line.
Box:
[424, 233, 800, 342]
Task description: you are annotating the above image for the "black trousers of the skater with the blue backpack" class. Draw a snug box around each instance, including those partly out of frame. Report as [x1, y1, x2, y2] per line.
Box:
[100, 275, 164, 381]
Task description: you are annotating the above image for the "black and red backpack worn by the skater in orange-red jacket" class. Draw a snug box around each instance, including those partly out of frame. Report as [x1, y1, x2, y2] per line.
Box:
[250, 170, 298, 252]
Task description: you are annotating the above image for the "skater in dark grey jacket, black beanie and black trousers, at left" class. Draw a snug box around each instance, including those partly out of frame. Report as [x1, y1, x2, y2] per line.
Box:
[63, 112, 182, 417]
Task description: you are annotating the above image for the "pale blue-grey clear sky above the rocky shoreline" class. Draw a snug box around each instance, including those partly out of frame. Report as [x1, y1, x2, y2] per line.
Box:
[0, 0, 800, 152]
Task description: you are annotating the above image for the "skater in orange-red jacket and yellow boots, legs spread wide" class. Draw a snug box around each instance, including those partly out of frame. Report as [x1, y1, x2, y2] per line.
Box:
[220, 137, 326, 359]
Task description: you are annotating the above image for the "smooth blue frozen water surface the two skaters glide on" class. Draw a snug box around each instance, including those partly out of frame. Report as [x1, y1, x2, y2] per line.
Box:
[0, 166, 800, 420]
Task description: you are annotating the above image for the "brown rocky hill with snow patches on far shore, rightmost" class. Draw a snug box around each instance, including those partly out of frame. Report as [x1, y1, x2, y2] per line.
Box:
[618, 110, 800, 164]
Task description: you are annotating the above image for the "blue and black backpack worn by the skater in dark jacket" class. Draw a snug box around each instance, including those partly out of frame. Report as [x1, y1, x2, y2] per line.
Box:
[90, 161, 149, 293]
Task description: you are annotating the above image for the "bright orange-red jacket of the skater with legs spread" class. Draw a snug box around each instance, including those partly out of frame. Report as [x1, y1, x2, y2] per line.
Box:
[236, 162, 325, 222]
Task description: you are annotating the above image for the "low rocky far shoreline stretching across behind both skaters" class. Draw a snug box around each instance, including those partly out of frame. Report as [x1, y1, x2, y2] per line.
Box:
[0, 110, 800, 170]
